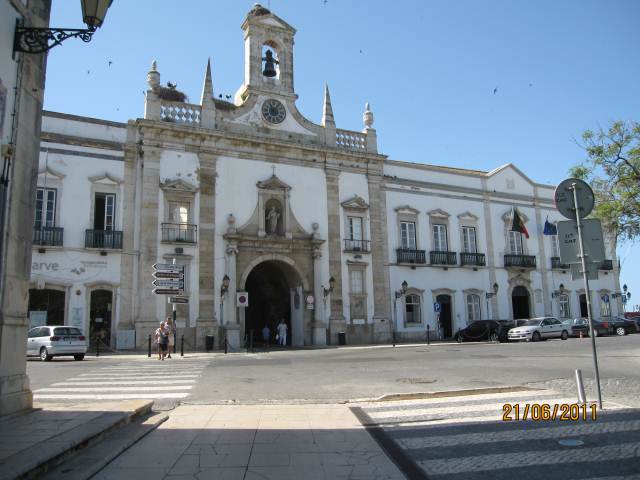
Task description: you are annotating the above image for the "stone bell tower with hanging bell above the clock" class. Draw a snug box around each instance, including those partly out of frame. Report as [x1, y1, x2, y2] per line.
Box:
[238, 4, 297, 101]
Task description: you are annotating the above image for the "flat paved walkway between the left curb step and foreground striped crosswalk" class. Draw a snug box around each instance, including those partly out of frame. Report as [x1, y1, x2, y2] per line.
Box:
[93, 404, 404, 480]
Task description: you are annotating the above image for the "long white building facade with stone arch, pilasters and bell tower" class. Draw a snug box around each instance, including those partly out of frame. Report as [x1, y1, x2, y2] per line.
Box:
[29, 6, 622, 348]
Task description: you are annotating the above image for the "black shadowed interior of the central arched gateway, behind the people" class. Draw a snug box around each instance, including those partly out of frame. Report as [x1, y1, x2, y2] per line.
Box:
[245, 261, 292, 345]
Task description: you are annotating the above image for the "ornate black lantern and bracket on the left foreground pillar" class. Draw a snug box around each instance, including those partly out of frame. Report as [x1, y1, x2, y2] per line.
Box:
[13, 0, 113, 53]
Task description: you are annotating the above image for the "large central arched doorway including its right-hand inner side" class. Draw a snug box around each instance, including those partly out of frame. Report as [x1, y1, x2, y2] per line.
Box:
[244, 260, 304, 346]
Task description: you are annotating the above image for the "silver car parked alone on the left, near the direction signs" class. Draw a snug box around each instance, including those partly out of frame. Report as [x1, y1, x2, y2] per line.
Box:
[27, 325, 87, 362]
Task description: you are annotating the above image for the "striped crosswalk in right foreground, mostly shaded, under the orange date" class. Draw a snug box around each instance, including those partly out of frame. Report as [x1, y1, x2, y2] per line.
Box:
[358, 390, 640, 480]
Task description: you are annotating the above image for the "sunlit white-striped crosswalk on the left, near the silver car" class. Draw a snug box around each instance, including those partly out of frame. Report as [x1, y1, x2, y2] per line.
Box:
[33, 359, 207, 402]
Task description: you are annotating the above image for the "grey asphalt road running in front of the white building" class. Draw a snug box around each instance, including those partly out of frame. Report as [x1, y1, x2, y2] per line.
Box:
[27, 335, 640, 406]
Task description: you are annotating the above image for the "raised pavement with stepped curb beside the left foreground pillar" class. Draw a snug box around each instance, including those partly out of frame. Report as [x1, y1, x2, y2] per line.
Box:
[0, 400, 153, 480]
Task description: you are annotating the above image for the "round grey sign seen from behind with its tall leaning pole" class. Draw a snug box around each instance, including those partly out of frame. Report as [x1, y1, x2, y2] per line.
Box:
[555, 178, 602, 409]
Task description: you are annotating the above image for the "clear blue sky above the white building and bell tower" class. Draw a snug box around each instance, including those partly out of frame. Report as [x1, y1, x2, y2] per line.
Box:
[45, 0, 640, 303]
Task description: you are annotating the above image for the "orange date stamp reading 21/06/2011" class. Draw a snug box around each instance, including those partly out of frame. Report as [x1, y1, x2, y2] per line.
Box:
[502, 403, 597, 422]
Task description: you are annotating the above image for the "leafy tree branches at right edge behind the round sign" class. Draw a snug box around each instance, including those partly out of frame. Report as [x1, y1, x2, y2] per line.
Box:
[570, 121, 640, 240]
